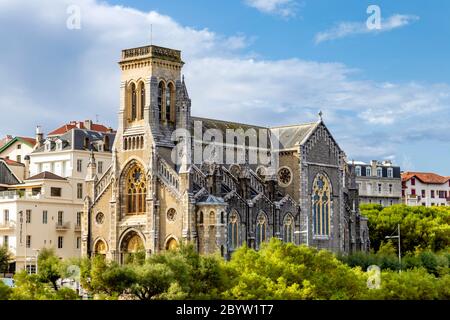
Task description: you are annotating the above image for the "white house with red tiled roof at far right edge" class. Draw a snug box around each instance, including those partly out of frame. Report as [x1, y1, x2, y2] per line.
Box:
[402, 172, 450, 207]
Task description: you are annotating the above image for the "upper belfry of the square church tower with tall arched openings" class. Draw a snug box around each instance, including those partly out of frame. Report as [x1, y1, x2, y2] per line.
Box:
[117, 45, 190, 150]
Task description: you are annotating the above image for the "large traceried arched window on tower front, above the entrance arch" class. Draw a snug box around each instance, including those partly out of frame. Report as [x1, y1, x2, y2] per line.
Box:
[126, 166, 147, 214]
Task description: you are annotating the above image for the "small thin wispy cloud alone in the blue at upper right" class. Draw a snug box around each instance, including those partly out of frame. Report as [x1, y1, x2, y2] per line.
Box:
[315, 14, 419, 44]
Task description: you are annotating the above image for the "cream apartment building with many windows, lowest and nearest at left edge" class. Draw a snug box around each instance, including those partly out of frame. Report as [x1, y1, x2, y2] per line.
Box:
[0, 172, 83, 272]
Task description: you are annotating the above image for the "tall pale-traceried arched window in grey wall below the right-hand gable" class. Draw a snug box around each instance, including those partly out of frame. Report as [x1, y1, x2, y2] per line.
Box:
[312, 173, 331, 236]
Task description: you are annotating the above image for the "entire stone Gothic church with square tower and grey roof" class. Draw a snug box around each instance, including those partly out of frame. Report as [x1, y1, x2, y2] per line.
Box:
[82, 45, 369, 263]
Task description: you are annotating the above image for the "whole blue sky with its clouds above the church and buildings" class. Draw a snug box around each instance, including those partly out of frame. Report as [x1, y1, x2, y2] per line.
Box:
[0, 0, 450, 175]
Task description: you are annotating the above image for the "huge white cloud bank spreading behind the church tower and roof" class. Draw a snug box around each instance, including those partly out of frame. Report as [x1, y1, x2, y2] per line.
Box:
[0, 0, 450, 168]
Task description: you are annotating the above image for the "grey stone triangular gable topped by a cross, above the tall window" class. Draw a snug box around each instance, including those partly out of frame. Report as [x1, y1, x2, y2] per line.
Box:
[302, 123, 342, 166]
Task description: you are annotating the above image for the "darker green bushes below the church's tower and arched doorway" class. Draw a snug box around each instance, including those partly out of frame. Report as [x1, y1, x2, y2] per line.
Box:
[81, 246, 226, 300]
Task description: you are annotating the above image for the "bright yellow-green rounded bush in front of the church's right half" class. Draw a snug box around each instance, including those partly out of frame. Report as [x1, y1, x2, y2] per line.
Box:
[224, 239, 367, 300]
